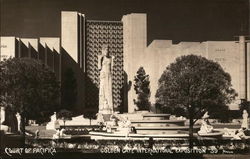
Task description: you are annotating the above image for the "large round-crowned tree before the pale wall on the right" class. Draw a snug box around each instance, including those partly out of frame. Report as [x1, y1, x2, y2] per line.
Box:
[156, 55, 237, 147]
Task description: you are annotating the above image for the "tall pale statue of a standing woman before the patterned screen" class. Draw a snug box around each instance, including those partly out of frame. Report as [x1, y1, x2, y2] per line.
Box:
[98, 45, 114, 114]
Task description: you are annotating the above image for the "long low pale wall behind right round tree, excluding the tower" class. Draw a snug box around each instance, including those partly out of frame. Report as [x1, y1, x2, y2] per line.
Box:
[143, 40, 244, 109]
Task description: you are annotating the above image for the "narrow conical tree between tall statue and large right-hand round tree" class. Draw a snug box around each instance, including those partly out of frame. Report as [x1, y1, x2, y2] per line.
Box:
[134, 67, 150, 110]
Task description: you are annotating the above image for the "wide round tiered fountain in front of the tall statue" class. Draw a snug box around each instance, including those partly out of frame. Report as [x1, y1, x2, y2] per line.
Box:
[89, 112, 200, 140]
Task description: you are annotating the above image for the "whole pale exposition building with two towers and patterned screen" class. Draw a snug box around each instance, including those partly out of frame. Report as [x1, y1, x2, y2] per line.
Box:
[0, 11, 250, 113]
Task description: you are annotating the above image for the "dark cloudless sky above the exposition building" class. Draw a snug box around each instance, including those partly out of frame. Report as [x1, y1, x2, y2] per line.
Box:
[0, 0, 249, 43]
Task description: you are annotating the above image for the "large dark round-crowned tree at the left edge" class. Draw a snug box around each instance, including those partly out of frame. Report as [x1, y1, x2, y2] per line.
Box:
[0, 58, 60, 143]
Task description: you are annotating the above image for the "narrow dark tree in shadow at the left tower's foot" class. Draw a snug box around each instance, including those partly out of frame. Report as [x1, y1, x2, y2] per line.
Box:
[62, 68, 77, 110]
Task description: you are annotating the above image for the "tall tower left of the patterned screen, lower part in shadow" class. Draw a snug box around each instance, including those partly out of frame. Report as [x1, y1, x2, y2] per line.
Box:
[61, 11, 85, 114]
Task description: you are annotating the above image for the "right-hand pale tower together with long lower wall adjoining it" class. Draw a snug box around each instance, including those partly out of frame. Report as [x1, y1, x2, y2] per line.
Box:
[122, 14, 250, 112]
